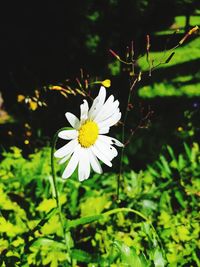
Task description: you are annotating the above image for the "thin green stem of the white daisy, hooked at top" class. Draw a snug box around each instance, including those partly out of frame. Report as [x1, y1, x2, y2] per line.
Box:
[51, 128, 72, 262]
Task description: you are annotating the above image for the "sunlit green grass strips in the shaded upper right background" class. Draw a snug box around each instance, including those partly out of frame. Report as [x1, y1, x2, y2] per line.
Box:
[138, 16, 200, 98]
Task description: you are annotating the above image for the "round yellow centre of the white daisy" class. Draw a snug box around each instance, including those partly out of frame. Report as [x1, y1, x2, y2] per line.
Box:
[78, 121, 99, 148]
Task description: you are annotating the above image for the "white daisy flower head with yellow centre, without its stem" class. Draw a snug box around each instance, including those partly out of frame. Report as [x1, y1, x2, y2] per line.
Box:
[54, 86, 123, 181]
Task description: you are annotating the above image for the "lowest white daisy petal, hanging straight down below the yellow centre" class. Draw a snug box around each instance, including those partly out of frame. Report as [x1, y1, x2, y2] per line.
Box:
[78, 148, 90, 182]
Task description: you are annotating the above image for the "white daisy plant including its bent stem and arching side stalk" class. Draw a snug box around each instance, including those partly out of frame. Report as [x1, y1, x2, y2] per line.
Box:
[51, 86, 159, 262]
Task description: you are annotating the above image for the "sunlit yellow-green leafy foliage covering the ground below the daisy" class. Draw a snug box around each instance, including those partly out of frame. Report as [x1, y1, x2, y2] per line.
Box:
[0, 143, 200, 267]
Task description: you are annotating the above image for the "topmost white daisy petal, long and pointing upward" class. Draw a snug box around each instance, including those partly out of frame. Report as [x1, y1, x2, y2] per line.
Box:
[88, 86, 106, 120]
